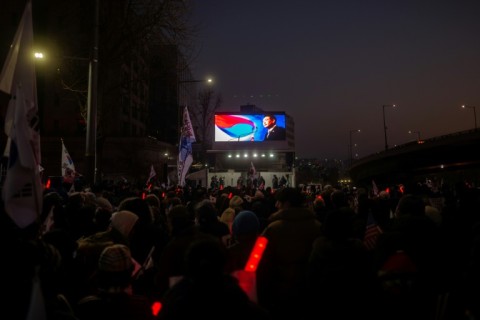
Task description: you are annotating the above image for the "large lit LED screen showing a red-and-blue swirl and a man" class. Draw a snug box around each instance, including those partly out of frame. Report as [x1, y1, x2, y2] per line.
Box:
[215, 112, 286, 142]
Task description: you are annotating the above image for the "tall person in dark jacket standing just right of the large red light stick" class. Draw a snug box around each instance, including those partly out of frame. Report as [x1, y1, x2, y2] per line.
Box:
[257, 187, 322, 319]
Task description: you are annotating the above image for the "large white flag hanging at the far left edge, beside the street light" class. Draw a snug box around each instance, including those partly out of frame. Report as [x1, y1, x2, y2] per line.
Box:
[0, 1, 43, 228]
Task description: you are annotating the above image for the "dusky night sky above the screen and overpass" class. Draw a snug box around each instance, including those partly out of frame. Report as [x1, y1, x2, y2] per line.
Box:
[189, 0, 480, 160]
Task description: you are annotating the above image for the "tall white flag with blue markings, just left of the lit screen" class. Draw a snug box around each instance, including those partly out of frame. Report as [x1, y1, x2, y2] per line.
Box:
[177, 107, 196, 187]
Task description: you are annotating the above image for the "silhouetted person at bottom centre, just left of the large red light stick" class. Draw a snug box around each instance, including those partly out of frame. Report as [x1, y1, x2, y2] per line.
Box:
[158, 236, 271, 320]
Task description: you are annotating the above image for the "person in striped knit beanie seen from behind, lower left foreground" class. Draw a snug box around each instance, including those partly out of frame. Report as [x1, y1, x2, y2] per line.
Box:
[76, 244, 154, 320]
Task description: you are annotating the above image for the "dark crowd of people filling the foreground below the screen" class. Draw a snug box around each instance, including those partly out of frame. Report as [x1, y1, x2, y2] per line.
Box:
[0, 179, 480, 320]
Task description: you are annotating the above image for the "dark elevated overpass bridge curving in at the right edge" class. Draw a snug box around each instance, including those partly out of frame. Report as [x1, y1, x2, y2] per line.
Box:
[349, 130, 480, 186]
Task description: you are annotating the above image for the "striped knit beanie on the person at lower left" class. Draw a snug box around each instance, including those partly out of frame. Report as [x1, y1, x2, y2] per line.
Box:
[98, 244, 133, 272]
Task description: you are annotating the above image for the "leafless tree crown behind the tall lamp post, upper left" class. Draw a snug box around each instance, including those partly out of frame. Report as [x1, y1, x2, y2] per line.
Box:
[47, 0, 196, 127]
